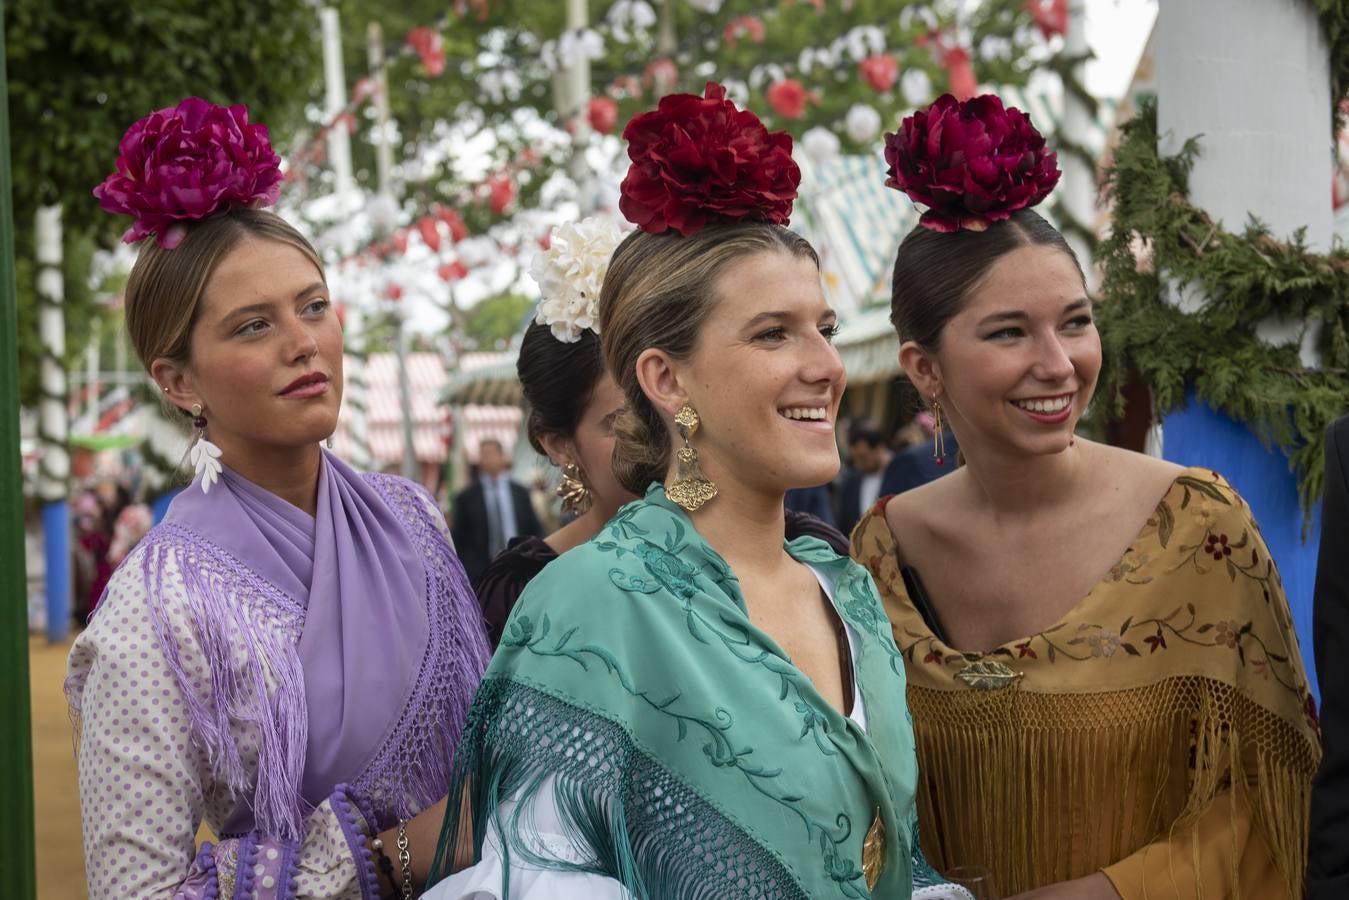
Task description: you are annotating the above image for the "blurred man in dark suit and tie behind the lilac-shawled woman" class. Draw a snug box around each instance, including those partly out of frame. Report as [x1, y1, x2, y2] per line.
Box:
[451, 439, 544, 582]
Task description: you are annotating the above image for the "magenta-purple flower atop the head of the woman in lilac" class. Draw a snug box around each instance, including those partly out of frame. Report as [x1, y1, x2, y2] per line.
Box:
[93, 97, 281, 250]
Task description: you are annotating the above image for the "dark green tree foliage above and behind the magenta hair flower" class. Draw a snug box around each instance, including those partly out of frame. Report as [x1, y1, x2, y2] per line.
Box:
[4, 0, 320, 402]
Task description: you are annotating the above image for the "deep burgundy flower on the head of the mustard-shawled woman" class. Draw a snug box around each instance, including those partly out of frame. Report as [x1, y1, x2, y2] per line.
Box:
[885, 93, 1062, 232]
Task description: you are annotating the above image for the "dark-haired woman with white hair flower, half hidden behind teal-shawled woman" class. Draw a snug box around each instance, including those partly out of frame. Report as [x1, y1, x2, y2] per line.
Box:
[475, 219, 847, 648]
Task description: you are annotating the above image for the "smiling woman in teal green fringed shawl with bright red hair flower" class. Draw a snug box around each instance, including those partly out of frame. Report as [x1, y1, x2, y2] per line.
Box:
[426, 85, 969, 900]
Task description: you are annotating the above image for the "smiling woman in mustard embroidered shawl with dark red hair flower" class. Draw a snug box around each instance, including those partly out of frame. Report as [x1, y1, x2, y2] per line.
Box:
[853, 96, 1319, 900]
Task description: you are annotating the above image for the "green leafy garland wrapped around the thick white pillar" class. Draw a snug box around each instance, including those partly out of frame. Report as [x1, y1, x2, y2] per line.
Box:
[1097, 100, 1349, 525]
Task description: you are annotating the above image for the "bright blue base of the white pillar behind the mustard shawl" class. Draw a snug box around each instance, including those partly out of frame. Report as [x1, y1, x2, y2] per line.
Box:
[1161, 393, 1321, 703]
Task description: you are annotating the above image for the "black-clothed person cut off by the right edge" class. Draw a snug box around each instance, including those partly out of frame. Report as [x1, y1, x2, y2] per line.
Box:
[1307, 417, 1349, 900]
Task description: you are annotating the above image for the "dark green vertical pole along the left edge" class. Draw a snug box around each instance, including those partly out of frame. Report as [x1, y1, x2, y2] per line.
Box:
[0, 0, 38, 900]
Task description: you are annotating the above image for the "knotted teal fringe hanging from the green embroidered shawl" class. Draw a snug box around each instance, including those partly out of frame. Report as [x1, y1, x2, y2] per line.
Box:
[432, 677, 805, 900]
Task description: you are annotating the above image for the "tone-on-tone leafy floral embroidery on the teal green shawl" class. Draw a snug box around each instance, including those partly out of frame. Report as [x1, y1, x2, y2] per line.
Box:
[485, 496, 917, 900]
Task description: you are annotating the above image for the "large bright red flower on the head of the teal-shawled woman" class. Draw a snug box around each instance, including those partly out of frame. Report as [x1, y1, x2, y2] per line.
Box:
[618, 81, 801, 237]
